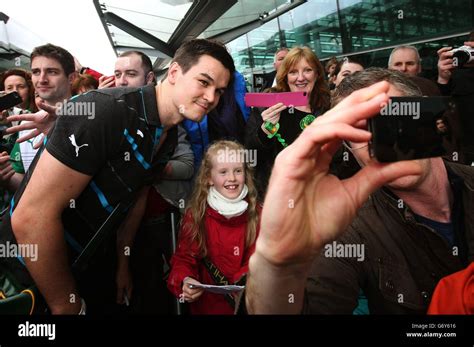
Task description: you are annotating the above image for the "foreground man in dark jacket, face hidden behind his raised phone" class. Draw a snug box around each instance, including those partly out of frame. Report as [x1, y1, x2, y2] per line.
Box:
[245, 68, 474, 314]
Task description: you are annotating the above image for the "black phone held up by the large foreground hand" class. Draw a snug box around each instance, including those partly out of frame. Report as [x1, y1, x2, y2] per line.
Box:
[368, 97, 462, 162]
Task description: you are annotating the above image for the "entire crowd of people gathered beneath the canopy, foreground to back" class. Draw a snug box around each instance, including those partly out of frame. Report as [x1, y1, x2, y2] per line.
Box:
[0, 32, 474, 314]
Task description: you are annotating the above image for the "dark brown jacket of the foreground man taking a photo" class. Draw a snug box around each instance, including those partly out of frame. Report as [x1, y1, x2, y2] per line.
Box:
[304, 163, 474, 314]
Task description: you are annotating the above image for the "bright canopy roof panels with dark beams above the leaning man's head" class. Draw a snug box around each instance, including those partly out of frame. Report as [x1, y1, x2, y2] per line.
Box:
[93, 0, 305, 67]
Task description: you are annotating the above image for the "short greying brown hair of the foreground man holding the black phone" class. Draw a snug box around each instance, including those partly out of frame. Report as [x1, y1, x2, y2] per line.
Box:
[332, 67, 422, 107]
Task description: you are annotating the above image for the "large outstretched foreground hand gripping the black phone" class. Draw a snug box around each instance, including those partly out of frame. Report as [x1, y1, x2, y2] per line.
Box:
[254, 82, 419, 267]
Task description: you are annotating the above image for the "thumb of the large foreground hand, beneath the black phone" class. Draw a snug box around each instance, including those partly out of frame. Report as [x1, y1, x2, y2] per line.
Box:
[342, 160, 422, 208]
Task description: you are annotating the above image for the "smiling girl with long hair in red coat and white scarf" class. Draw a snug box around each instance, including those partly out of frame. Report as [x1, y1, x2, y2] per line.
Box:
[168, 141, 261, 314]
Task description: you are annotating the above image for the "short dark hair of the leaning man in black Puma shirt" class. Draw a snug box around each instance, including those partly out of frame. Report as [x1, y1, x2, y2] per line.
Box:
[172, 39, 235, 84]
